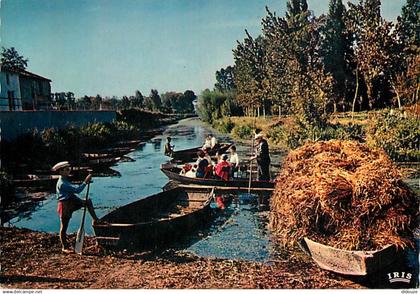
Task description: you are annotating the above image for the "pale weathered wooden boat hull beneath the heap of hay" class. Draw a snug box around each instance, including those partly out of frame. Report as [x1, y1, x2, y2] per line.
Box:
[300, 238, 398, 276]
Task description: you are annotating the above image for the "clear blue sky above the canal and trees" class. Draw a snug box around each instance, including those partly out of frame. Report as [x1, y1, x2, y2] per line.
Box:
[0, 0, 405, 96]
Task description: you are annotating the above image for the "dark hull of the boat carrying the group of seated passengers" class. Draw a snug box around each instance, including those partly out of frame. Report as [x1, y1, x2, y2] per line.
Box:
[160, 164, 275, 189]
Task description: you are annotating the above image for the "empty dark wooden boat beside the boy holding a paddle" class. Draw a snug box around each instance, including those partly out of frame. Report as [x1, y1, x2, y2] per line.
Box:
[93, 188, 213, 249]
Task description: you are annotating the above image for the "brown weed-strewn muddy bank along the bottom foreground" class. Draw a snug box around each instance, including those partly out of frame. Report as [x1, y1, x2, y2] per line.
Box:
[0, 228, 365, 289]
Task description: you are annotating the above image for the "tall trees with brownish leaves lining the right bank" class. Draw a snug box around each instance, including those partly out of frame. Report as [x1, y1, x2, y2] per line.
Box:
[200, 0, 420, 122]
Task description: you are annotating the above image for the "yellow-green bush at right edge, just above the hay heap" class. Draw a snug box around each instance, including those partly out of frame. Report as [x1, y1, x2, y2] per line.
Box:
[366, 113, 420, 161]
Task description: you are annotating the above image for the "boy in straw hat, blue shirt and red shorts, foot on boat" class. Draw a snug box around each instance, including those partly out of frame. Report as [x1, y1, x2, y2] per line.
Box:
[52, 161, 99, 253]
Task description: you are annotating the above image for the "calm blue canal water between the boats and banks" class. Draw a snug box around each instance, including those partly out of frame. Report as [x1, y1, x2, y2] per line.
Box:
[9, 119, 278, 261]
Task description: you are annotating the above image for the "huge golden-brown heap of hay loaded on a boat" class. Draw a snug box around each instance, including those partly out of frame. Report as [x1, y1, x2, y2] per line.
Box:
[270, 141, 418, 250]
